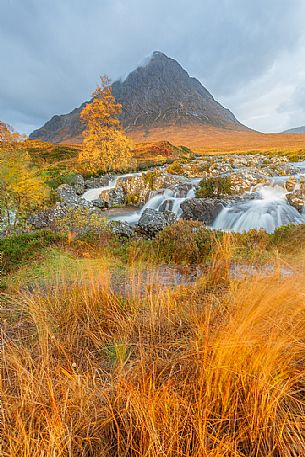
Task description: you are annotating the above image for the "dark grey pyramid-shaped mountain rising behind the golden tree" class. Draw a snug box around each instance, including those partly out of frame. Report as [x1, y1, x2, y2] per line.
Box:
[30, 51, 247, 143]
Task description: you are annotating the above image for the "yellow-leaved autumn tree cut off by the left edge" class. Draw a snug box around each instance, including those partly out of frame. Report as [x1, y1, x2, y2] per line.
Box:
[0, 122, 49, 231]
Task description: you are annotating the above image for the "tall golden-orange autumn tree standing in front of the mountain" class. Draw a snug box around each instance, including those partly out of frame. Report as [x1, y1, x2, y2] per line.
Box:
[79, 76, 132, 173]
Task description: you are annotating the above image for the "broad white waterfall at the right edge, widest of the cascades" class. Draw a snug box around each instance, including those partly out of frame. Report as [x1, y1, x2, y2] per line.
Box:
[213, 185, 305, 233]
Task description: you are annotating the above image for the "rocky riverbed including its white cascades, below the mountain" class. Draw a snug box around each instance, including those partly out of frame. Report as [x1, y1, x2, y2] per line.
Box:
[29, 155, 305, 237]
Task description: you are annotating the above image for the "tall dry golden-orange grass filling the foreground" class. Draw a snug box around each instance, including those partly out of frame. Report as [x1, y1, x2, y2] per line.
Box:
[1, 251, 305, 457]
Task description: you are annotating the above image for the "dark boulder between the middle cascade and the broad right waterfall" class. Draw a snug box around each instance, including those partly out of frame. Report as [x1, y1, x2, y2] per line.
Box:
[181, 198, 225, 225]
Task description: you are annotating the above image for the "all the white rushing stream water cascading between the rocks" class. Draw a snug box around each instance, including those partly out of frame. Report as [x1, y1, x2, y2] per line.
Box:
[83, 162, 305, 233]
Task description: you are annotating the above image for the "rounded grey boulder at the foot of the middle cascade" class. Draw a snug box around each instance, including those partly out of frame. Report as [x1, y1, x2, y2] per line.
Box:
[137, 208, 177, 238]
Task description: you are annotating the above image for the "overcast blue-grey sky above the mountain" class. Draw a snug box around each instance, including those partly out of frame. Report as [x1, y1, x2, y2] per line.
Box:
[0, 0, 305, 133]
